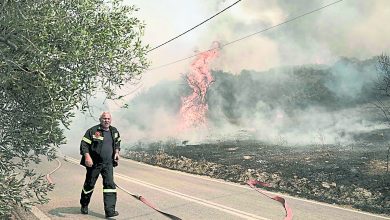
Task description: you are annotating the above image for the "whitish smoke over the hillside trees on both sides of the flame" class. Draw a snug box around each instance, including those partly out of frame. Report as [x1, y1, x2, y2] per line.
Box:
[108, 55, 385, 145]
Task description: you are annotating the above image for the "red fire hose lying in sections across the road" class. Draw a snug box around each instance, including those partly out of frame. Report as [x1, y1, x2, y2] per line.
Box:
[46, 156, 293, 220]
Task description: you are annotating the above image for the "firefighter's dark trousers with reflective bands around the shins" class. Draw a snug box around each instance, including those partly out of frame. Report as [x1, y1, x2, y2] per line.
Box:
[80, 164, 116, 213]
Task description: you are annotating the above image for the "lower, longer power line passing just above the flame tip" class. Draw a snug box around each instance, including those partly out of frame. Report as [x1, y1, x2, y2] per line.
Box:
[148, 0, 344, 71]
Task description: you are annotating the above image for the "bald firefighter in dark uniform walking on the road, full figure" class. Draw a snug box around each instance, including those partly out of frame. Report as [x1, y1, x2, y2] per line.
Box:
[80, 112, 121, 217]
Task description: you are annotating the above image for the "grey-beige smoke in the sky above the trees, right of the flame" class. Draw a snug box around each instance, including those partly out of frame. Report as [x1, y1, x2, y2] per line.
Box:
[201, 0, 390, 74]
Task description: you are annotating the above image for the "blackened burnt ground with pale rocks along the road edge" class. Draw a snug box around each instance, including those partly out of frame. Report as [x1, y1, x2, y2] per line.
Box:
[124, 140, 390, 215]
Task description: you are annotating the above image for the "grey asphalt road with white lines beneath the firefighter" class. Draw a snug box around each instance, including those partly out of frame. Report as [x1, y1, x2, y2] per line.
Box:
[33, 157, 390, 220]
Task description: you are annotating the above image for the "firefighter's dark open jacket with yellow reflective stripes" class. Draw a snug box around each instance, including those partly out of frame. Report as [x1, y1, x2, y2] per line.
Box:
[80, 124, 121, 166]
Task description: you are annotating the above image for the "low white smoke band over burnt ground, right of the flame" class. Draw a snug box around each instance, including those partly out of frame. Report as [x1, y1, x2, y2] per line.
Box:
[236, 106, 386, 145]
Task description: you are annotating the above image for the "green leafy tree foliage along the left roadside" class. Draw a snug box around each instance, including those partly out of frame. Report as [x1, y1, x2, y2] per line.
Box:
[0, 0, 149, 216]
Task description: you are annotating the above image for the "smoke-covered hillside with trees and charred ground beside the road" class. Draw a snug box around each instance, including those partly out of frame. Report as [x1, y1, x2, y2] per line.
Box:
[125, 55, 390, 215]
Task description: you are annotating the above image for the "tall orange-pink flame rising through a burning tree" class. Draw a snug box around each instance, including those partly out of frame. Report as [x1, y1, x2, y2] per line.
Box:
[180, 42, 219, 129]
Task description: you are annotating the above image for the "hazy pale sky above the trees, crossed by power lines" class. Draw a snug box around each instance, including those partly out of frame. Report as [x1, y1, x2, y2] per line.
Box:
[60, 0, 390, 155]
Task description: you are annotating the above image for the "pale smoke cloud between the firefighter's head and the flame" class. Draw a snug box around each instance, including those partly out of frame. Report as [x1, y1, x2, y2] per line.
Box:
[114, 81, 184, 142]
